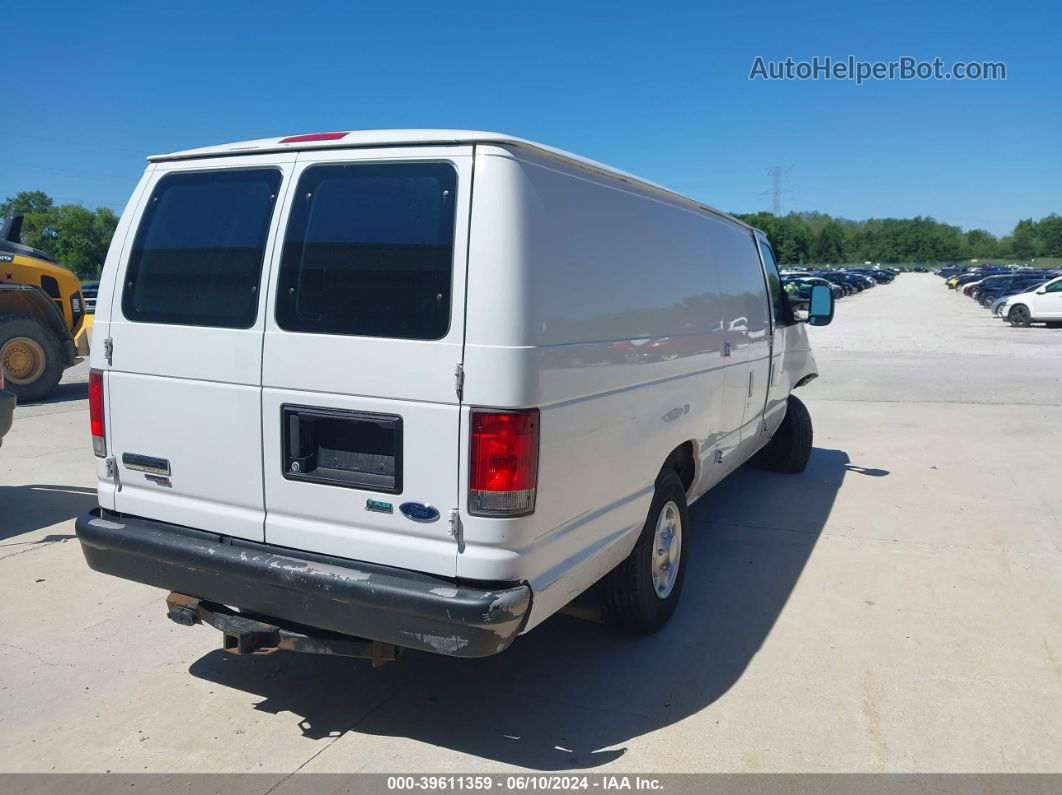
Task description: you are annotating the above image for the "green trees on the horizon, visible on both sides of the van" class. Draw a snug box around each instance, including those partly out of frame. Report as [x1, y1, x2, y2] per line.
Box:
[0, 191, 1062, 276]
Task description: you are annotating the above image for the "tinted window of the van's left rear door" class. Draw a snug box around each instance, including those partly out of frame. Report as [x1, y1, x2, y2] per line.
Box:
[122, 169, 280, 328]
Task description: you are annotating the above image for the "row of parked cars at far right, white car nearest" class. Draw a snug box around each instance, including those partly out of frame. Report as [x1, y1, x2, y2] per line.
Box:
[937, 265, 1062, 327]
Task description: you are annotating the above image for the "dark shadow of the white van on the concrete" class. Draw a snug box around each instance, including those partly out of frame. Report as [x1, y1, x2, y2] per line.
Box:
[189, 448, 850, 771]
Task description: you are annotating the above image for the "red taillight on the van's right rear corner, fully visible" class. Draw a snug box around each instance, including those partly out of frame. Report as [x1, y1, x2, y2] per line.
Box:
[468, 409, 538, 516]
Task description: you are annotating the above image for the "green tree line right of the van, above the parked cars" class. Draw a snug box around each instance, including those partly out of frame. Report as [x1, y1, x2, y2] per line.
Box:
[735, 212, 1062, 265]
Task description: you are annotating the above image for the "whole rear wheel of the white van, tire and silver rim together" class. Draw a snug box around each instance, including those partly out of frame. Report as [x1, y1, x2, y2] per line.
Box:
[603, 469, 689, 634]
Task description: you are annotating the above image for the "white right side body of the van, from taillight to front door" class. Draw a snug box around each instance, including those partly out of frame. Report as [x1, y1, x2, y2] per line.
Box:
[458, 146, 766, 627]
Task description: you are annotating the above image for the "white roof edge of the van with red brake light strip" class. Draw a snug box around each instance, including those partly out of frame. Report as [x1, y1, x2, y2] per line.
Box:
[148, 129, 759, 231]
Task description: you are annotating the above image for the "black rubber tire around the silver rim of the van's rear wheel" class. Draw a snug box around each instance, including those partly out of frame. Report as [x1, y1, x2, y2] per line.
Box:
[602, 469, 689, 635]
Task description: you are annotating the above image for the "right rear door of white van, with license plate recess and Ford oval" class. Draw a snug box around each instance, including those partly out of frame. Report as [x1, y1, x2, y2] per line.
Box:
[262, 146, 473, 576]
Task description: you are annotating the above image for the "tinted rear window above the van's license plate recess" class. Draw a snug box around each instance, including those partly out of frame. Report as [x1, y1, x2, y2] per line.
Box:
[276, 162, 457, 340]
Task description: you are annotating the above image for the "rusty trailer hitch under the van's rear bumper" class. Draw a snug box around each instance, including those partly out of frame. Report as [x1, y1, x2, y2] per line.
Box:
[166, 591, 401, 668]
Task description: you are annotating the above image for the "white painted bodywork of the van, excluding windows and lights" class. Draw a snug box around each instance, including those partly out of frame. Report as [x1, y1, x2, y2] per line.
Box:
[84, 131, 817, 658]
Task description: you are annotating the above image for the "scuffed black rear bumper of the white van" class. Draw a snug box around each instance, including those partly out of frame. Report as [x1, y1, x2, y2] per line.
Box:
[76, 508, 531, 657]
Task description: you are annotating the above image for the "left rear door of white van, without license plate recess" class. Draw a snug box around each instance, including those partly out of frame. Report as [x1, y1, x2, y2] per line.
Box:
[105, 153, 295, 540]
